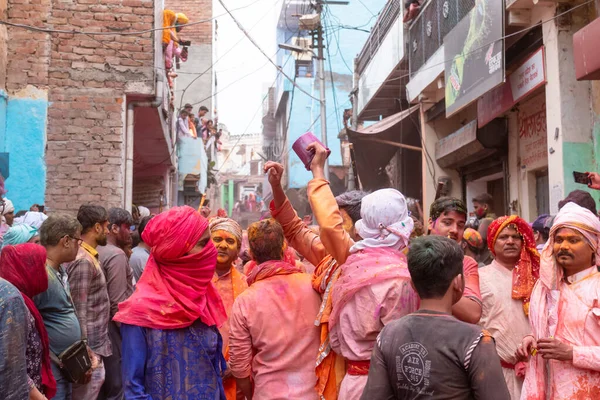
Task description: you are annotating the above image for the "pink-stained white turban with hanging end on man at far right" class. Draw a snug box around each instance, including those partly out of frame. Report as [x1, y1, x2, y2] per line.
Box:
[540, 203, 600, 289]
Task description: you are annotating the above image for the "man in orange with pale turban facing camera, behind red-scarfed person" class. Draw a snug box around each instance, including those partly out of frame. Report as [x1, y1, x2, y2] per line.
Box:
[209, 218, 248, 400]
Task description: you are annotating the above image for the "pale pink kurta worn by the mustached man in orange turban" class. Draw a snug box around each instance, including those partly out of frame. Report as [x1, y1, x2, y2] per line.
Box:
[479, 260, 531, 400]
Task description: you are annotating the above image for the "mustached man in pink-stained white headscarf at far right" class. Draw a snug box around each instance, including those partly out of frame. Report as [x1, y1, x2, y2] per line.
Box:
[517, 203, 600, 400]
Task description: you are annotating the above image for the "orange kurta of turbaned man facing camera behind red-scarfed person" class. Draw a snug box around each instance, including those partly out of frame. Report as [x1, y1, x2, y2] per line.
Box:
[212, 267, 248, 400]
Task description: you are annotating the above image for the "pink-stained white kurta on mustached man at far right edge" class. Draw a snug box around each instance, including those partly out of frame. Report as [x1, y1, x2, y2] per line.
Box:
[521, 267, 600, 400]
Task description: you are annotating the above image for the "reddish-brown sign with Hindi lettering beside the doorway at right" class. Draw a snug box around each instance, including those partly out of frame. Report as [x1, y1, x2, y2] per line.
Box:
[518, 94, 548, 170]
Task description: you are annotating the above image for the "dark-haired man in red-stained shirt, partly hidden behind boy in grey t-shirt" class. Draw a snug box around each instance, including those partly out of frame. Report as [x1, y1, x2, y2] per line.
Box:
[428, 197, 481, 324]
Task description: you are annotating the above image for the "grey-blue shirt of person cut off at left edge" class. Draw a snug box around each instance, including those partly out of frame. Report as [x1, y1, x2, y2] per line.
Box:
[0, 278, 29, 400]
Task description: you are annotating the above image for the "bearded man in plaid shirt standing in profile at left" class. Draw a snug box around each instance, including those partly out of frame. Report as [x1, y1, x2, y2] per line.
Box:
[67, 205, 112, 400]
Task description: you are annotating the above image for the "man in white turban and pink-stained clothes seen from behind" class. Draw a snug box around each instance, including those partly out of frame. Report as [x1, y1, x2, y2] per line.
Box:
[329, 189, 419, 400]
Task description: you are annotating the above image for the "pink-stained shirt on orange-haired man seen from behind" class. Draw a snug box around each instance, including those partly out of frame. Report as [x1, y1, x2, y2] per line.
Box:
[229, 273, 321, 400]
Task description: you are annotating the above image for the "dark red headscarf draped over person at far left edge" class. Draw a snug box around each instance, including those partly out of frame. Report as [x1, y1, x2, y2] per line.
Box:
[0, 243, 56, 399]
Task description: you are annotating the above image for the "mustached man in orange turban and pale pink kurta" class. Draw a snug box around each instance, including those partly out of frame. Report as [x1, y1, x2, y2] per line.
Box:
[479, 215, 540, 400]
